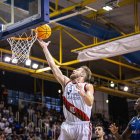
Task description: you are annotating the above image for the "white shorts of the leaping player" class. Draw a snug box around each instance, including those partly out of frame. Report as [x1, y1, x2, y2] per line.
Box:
[58, 121, 92, 140]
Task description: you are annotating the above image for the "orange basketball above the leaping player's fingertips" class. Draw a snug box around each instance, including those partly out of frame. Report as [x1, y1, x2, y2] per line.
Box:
[36, 24, 52, 39]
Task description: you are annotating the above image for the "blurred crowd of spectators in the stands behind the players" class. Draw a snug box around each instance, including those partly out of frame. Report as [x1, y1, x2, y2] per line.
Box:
[0, 101, 128, 140]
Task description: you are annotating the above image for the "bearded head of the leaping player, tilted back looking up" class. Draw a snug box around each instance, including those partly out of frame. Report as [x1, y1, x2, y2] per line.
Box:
[70, 66, 91, 82]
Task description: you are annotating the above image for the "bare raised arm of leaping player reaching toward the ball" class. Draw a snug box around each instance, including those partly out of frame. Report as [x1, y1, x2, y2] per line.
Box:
[38, 40, 69, 87]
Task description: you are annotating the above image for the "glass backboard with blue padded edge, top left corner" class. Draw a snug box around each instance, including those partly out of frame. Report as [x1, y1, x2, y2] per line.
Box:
[0, 0, 49, 39]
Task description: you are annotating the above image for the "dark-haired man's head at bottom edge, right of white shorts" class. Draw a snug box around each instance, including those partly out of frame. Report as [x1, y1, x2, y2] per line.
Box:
[95, 124, 105, 140]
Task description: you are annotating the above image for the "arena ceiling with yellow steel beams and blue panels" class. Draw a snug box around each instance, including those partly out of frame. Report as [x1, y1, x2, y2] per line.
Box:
[0, 0, 140, 98]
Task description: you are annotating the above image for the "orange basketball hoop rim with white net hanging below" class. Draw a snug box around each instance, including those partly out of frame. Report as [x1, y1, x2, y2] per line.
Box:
[7, 30, 37, 63]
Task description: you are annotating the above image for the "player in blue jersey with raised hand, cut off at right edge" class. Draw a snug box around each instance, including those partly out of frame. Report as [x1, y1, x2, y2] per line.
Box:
[109, 98, 140, 140]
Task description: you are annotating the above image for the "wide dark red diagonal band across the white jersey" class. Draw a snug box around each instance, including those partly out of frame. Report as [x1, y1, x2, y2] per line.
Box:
[63, 96, 90, 121]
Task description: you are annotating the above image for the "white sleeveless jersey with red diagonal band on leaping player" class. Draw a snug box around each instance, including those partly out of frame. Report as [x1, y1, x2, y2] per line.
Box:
[63, 81, 92, 122]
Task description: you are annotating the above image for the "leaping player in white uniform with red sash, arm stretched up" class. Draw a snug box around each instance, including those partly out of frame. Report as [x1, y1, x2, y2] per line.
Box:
[39, 40, 94, 140]
